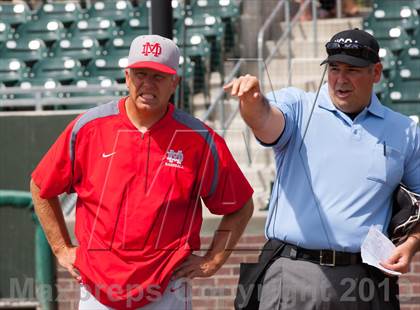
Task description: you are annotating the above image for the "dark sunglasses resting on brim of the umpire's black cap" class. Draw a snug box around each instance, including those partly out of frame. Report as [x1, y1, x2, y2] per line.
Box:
[325, 42, 380, 63]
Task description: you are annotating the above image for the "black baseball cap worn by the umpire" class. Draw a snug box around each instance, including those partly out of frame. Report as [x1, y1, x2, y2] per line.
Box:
[321, 28, 380, 67]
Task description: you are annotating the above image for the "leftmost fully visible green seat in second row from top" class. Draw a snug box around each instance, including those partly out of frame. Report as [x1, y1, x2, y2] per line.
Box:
[15, 20, 67, 45]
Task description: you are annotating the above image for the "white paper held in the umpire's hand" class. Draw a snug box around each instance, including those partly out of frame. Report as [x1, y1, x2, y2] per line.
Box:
[361, 226, 401, 276]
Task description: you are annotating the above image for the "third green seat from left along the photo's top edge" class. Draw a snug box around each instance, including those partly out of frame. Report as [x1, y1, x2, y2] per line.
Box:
[87, 0, 134, 22]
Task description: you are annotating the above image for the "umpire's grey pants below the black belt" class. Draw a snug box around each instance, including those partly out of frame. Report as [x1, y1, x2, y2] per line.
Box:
[259, 257, 399, 310]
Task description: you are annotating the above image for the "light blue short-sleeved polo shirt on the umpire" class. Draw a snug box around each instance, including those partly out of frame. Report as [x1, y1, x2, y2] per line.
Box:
[266, 84, 420, 252]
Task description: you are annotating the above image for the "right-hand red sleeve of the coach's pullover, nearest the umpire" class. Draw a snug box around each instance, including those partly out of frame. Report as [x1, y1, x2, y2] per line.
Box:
[202, 132, 253, 215]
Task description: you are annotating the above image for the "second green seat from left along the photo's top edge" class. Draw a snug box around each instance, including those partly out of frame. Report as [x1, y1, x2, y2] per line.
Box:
[33, 1, 85, 27]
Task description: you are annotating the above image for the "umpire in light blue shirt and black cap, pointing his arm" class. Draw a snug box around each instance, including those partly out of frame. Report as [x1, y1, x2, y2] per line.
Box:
[225, 29, 420, 310]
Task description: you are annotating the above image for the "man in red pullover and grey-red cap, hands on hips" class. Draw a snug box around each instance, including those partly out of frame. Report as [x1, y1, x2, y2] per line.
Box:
[31, 35, 253, 310]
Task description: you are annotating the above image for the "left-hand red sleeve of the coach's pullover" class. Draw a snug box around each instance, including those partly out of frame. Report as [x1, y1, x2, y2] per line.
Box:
[31, 119, 77, 199]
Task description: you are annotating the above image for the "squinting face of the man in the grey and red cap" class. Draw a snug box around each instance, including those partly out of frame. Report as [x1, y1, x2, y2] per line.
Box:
[125, 68, 179, 112]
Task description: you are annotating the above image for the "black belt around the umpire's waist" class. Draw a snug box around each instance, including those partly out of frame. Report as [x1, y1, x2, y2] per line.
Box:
[278, 243, 362, 267]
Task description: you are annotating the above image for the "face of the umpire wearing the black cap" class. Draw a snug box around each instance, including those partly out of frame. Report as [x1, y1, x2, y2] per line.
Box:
[328, 62, 382, 113]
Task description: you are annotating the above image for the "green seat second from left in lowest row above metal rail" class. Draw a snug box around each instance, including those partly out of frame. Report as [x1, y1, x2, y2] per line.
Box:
[30, 57, 83, 84]
